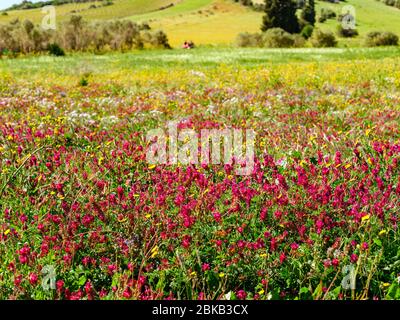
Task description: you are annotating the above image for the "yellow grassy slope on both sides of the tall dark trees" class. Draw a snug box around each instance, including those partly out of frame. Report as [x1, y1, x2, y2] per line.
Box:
[131, 0, 400, 46]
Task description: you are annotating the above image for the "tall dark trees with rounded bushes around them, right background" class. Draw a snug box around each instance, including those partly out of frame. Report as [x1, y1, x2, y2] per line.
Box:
[237, 0, 400, 48]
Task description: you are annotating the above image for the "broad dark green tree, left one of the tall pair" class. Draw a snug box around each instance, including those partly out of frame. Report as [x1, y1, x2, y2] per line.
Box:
[261, 0, 300, 33]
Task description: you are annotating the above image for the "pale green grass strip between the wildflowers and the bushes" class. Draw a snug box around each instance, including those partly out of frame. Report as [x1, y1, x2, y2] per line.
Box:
[0, 47, 400, 81]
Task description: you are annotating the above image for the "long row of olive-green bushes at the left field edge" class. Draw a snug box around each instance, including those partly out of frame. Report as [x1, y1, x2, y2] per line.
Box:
[0, 15, 170, 55]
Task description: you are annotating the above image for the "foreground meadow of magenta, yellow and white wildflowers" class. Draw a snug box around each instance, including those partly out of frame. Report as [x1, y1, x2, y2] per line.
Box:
[0, 59, 400, 299]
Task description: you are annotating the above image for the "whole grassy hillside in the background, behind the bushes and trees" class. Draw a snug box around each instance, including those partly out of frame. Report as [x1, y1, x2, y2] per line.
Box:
[0, 0, 400, 46]
